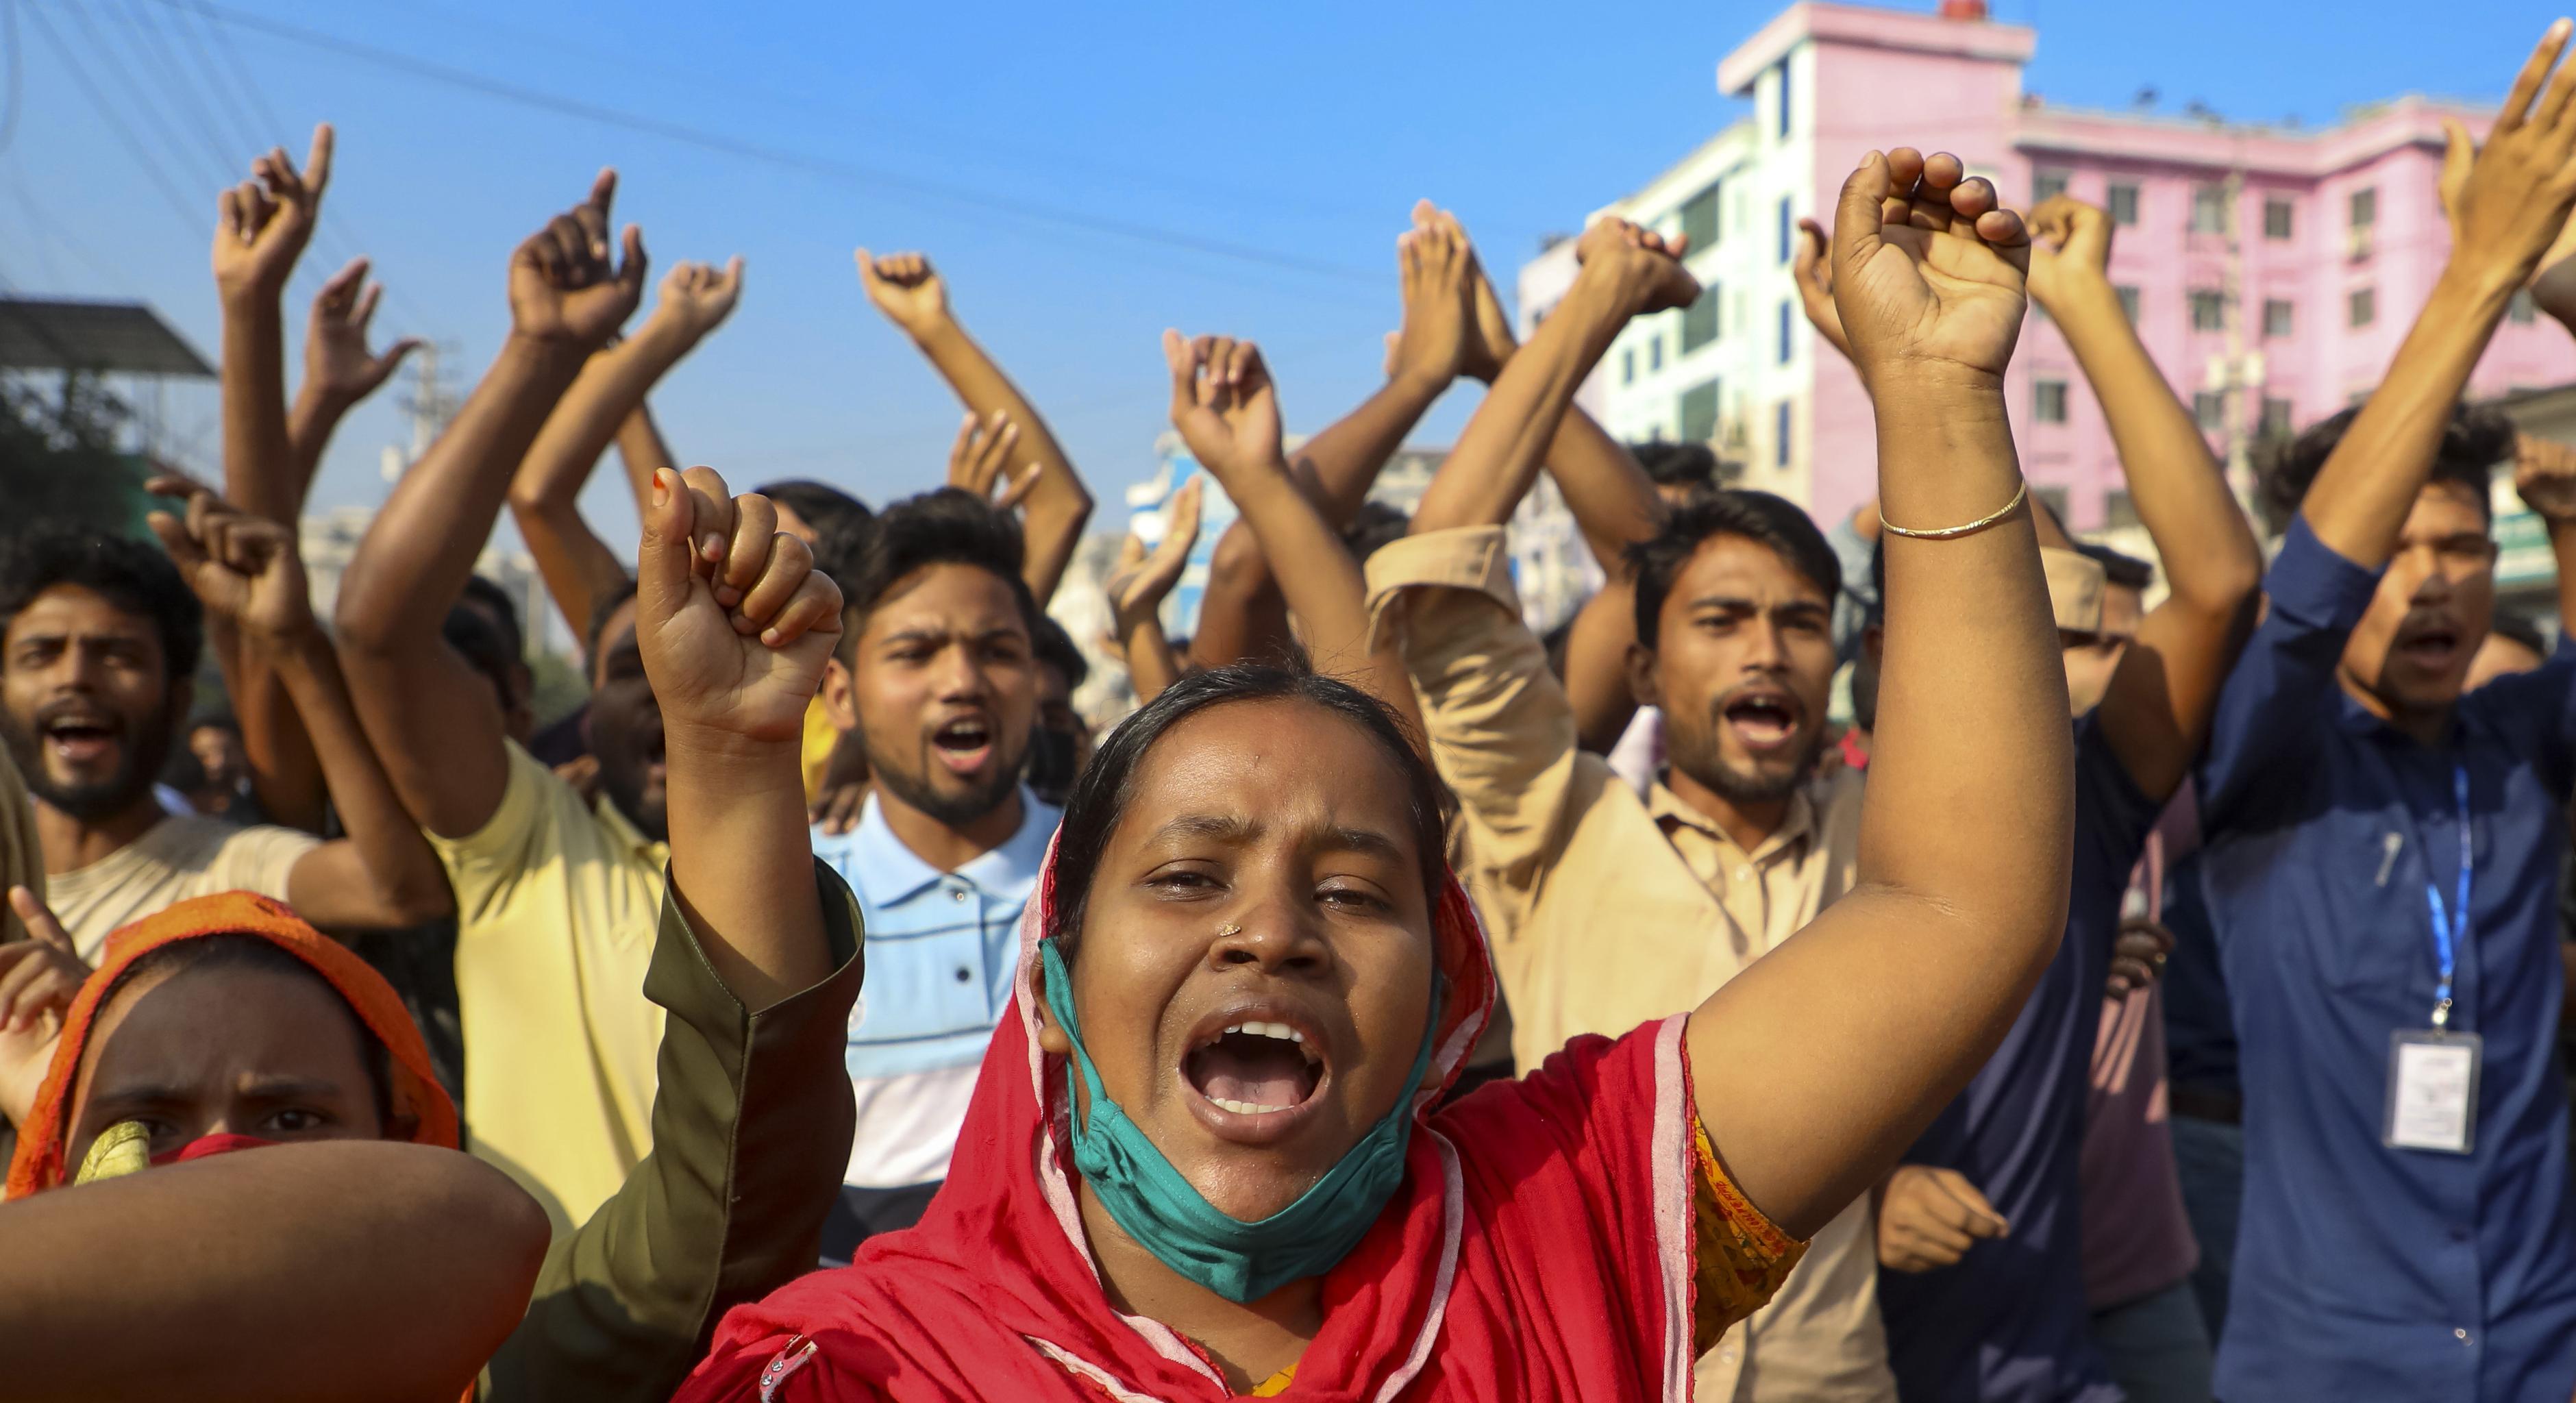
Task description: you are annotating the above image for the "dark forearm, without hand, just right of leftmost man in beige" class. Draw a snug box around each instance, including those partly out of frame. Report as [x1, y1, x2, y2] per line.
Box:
[275, 628, 451, 919]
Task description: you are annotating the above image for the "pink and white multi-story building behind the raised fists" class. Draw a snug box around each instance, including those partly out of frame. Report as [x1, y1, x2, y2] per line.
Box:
[1520, 0, 2576, 527]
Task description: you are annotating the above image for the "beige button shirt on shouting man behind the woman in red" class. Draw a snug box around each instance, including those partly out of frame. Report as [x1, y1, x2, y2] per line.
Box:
[1368, 527, 1896, 1403]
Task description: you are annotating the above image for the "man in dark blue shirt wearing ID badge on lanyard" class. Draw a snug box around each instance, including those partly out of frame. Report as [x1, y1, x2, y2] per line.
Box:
[2200, 21, 2576, 1403]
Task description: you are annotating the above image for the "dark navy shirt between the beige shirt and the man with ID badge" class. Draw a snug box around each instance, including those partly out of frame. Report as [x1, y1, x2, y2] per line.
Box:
[1878, 716, 2162, 1403]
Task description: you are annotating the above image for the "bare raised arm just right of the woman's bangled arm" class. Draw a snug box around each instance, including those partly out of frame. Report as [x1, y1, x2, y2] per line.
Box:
[2030, 196, 2262, 798]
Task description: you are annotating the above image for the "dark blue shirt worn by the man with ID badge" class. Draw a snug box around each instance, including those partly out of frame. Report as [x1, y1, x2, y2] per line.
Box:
[2200, 520, 2576, 1403]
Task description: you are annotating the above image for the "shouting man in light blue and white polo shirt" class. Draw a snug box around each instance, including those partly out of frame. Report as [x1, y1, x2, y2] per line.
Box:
[814, 489, 1061, 1261]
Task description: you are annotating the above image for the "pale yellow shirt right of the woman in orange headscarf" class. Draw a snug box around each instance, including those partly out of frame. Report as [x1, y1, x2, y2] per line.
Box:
[430, 744, 670, 1233]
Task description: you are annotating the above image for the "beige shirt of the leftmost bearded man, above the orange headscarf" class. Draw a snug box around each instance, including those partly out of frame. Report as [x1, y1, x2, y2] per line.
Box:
[47, 813, 322, 968]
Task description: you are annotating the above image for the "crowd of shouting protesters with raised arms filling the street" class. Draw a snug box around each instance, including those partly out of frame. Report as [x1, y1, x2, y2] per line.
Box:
[0, 21, 2576, 1403]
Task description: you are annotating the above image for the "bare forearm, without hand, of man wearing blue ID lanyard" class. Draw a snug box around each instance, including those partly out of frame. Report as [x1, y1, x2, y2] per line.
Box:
[2301, 262, 2514, 569]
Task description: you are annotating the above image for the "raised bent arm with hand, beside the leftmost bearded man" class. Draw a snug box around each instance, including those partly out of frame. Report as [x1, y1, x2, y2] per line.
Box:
[149, 479, 454, 930]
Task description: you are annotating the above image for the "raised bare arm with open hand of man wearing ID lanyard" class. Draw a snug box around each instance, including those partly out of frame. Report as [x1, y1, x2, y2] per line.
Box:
[2301, 21, 2576, 569]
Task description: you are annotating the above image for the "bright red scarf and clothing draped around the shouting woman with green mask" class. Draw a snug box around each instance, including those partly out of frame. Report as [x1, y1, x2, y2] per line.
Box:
[678, 839, 1692, 1403]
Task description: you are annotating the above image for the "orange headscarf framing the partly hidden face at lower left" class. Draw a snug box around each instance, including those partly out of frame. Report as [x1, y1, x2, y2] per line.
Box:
[0, 891, 458, 1200]
